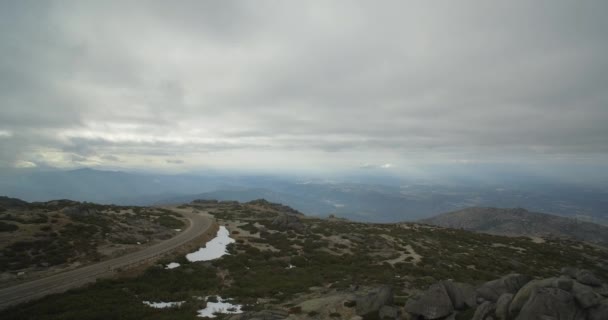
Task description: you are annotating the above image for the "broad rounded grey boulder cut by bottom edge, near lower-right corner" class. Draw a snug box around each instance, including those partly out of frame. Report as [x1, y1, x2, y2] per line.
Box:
[515, 288, 585, 320]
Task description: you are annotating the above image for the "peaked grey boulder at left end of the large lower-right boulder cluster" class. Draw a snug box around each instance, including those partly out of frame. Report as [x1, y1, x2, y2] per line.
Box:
[405, 283, 454, 319]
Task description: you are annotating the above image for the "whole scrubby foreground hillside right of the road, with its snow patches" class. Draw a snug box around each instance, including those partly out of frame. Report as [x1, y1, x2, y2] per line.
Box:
[0, 200, 608, 320]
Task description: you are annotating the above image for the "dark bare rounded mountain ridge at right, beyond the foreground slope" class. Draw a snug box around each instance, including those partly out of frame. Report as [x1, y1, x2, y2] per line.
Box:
[420, 207, 608, 245]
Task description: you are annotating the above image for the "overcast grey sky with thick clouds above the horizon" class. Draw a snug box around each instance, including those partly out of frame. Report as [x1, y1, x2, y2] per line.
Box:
[0, 0, 608, 172]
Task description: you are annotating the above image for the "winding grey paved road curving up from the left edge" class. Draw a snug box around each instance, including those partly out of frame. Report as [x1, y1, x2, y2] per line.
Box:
[0, 210, 212, 309]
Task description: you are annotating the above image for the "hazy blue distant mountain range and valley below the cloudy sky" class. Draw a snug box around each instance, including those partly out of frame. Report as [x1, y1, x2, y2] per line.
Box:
[0, 168, 608, 224]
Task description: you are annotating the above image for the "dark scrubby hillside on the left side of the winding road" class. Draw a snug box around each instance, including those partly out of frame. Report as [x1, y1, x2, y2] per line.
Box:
[0, 197, 185, 287]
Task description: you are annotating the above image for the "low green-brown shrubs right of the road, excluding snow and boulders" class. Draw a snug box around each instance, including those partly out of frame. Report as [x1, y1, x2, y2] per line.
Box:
[0, 201, 608, 319]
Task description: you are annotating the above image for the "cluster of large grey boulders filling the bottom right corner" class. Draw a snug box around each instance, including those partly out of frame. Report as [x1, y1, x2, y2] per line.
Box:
[405, 268, 608, 320]
